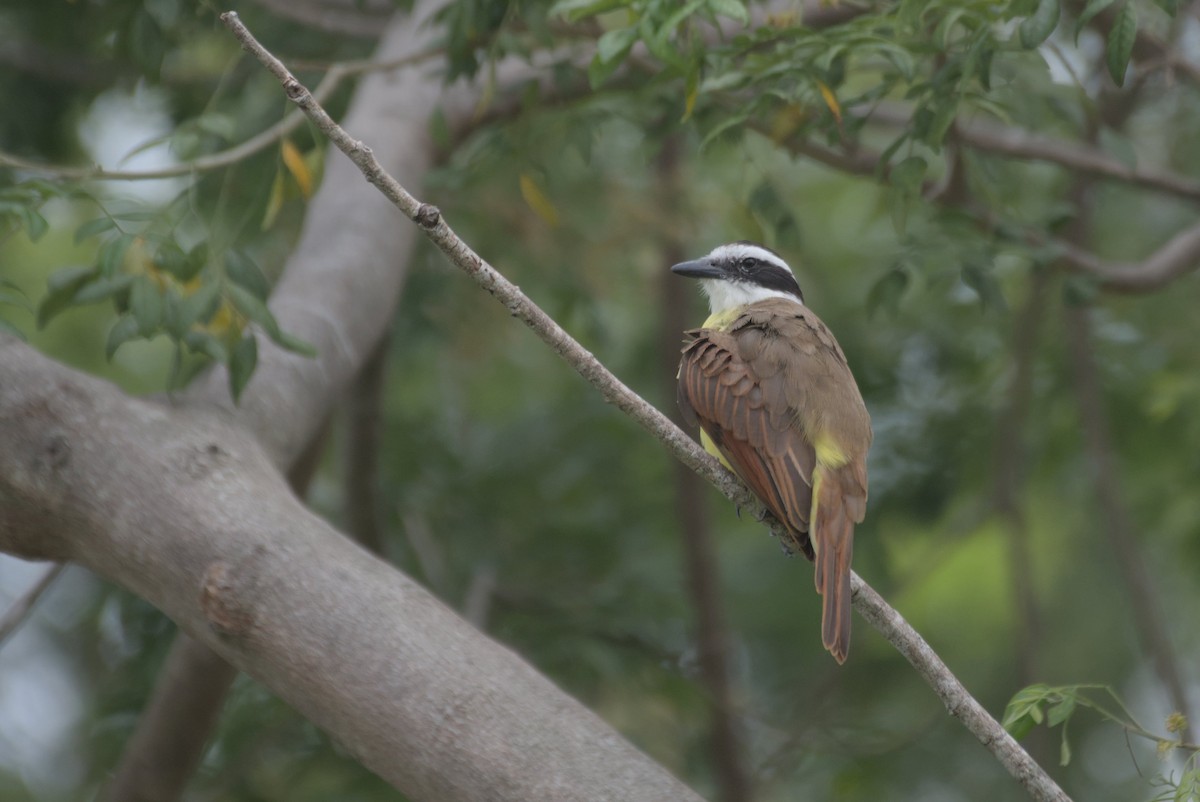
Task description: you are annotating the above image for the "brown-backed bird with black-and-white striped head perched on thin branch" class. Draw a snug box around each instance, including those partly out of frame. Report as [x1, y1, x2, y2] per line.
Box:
[671, 241, 871, 663]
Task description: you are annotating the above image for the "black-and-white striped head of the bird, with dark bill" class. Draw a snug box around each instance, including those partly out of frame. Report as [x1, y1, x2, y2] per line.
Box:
[671, 240, 804, 315]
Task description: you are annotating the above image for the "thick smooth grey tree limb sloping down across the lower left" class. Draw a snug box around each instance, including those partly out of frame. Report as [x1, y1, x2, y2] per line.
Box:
[0, 335, 698, 802]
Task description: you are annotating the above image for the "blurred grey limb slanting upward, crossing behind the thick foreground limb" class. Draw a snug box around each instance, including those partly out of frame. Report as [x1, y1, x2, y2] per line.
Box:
[98, 4, 451, 802]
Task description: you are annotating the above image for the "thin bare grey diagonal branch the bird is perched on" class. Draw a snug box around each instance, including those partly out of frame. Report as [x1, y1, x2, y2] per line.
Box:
[221, 12, 1069, 802]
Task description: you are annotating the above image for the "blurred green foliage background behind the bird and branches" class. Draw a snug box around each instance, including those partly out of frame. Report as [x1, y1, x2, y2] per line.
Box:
[0, 0, 1200, 801]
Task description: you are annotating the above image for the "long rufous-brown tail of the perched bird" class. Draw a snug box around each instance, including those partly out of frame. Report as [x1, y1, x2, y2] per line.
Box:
[809, 463, 864, 663]
